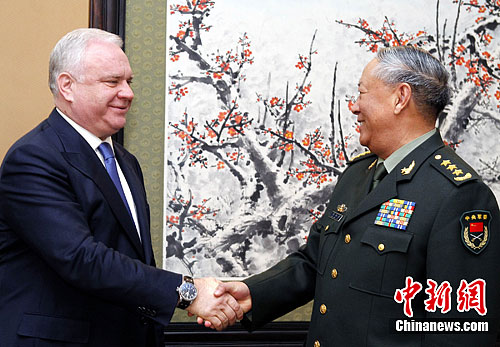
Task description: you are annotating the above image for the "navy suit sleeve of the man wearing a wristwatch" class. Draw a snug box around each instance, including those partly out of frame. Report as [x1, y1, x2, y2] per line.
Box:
[0, 144, 181, 325]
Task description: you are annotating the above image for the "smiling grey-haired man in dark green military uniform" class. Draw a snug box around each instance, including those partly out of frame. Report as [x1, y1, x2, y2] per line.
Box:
[214, 47, 500, 347]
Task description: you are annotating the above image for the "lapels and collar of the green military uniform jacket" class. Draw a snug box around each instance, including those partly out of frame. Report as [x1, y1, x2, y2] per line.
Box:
[344, 133, 444, 223]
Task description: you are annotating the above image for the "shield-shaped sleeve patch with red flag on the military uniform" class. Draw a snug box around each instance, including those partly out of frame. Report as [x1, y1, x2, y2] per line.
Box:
[460, 210, 491, 254]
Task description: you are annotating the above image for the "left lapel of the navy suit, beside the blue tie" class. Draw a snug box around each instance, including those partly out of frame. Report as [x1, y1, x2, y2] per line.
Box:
[49, 110, 144, 260]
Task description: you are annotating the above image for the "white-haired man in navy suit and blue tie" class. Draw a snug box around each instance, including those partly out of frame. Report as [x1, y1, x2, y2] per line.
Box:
[0, 29, 243, 347]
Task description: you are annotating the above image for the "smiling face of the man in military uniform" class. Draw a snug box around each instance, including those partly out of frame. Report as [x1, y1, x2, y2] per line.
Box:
[352, 59, 398, 159]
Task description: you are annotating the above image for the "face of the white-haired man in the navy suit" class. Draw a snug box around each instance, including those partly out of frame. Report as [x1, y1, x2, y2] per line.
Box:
[68, 41, 134, 139]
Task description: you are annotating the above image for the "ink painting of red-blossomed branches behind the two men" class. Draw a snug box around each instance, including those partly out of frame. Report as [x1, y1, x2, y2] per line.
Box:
[163, 0, 500, 278]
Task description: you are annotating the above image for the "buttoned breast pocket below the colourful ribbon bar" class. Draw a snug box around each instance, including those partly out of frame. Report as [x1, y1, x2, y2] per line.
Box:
[350, 226, 413, 298]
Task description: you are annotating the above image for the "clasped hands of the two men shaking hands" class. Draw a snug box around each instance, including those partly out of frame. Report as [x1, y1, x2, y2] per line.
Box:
[186, 278, 252, 331]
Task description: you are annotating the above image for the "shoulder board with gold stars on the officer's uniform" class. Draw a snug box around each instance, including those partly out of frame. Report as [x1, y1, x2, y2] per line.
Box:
[431, 153, 479, 186]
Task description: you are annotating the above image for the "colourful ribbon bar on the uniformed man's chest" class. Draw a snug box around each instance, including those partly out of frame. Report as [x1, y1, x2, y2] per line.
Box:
[375, 199, 415, 230]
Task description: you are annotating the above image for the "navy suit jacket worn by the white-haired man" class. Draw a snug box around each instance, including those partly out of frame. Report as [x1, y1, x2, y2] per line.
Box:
[0, 110, 181, 347]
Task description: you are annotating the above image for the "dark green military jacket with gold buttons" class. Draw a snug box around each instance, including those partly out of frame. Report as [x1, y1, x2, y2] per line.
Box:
[245, 134, 500, 346]
